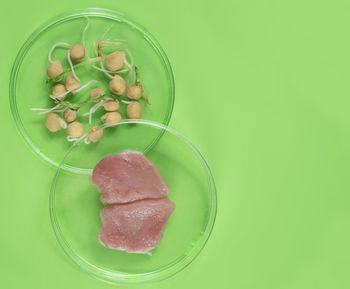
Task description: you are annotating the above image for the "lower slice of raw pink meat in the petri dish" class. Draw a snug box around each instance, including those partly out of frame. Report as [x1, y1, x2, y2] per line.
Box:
[99, 198, 175, 253]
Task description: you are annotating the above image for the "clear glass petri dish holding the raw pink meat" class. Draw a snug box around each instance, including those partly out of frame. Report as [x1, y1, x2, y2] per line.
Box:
[50, 120, 217, 285]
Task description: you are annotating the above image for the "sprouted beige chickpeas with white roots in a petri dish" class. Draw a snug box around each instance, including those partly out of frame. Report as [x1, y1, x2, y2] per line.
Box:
[41, 20, 149, 143]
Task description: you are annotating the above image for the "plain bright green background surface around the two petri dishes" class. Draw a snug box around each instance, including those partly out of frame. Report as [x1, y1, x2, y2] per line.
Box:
[0, 0, 350, 289]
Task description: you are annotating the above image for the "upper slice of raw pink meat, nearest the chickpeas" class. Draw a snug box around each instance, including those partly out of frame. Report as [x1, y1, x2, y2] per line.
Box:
[91, 151, 170, 204]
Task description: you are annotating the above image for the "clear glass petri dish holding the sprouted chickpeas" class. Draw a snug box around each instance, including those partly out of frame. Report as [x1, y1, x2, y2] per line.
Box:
[10, 8, 175, 171]
